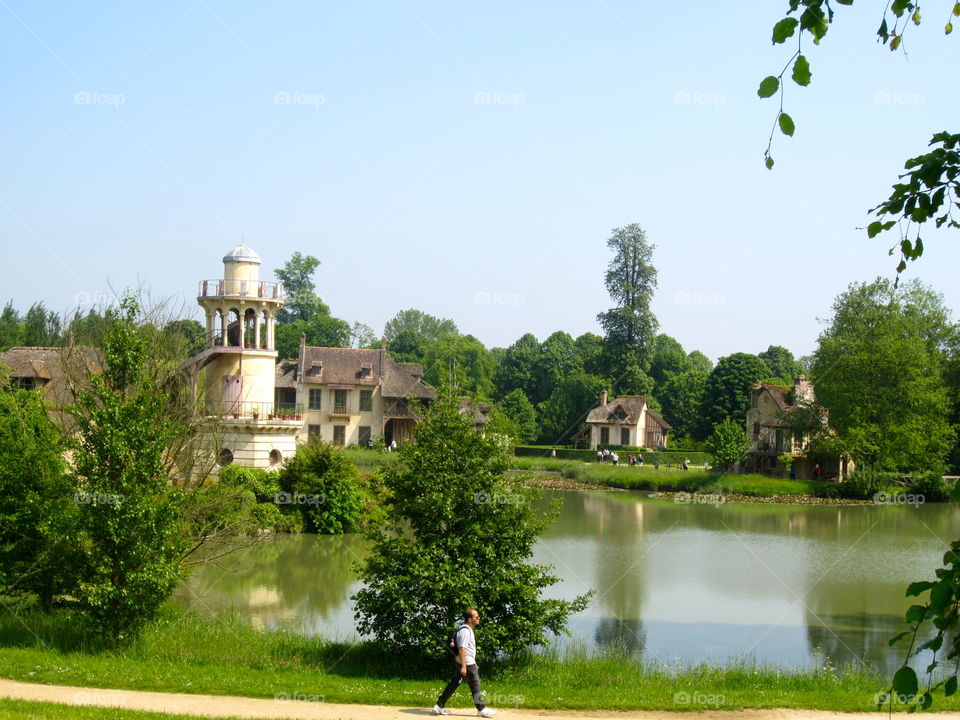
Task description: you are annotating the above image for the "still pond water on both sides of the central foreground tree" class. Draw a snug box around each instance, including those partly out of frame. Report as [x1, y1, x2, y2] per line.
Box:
[177, 491, 960, 672]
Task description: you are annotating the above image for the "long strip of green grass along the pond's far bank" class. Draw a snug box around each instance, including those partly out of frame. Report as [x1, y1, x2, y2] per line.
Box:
[511, 457, 830, 497]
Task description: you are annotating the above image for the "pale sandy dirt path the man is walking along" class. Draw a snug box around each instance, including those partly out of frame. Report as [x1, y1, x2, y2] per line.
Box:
[0, 679, 960, 720]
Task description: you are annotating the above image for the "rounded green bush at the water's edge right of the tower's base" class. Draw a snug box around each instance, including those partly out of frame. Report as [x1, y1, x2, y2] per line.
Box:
[277, 442, 364, 535]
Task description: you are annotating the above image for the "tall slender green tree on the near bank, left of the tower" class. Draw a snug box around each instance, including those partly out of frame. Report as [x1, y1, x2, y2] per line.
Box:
[67, 297, 185, 644]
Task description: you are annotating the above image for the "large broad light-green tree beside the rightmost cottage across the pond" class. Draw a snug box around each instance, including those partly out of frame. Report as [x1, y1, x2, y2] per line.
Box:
[813, 279, 960, 471]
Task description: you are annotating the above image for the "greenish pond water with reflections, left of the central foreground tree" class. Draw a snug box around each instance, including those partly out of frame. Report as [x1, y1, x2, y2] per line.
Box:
[177, 534, 365, 626]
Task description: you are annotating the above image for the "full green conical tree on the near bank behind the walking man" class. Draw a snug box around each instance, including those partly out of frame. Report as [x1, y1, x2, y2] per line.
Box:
[353, 388, 588, 654]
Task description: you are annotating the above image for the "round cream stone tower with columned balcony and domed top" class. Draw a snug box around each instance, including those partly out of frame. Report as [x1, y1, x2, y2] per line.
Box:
[194, 244, 302, 467]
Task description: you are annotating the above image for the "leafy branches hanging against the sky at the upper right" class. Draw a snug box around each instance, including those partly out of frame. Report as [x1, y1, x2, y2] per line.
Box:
[757, 0, 960, 275]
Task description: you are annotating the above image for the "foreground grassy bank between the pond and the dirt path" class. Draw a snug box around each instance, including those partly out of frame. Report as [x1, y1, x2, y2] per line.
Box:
[0, 608, 944, 717]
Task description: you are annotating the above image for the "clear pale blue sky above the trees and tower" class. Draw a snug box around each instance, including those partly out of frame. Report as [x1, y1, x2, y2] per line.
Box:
[0, 0, 960, 360]
